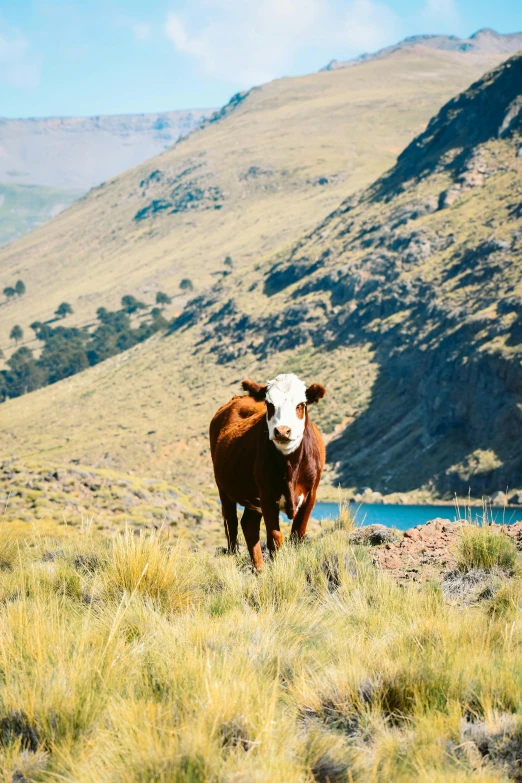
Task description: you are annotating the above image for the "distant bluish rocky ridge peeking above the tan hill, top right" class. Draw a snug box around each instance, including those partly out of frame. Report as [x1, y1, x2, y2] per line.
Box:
[323, 27, 522, 71]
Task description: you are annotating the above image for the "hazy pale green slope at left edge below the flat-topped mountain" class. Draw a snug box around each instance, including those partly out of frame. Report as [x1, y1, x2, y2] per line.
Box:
[0, 184, 83, 245]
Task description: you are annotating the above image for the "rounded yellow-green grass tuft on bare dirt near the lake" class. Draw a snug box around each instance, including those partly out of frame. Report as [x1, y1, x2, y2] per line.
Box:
[456, 525, 518, 572]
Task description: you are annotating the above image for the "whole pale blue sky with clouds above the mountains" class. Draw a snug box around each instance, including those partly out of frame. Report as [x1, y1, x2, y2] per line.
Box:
[0, 0, 522, 117]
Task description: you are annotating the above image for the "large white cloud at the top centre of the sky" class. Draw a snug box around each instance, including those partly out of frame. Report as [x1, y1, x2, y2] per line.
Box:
[164, 0, 399, 86]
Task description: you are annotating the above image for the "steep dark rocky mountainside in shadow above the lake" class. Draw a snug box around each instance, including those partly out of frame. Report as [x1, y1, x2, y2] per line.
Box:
[174, 56, 522, 495]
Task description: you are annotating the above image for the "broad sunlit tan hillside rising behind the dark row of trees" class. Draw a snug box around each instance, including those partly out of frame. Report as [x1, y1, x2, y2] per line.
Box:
[0, 47, 501, 350]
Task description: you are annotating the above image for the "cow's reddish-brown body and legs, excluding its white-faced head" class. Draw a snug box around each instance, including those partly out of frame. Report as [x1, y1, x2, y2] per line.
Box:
[210, 396, 325, 570]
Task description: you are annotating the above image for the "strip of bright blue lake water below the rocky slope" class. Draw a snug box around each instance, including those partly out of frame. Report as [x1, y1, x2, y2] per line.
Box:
[312, 503, 522, 530]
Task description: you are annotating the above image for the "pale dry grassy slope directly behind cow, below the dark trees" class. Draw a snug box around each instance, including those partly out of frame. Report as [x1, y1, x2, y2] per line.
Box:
[0, 330, 376, 498]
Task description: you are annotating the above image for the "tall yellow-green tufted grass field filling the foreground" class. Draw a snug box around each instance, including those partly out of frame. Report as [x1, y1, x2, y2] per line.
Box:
[0, 520, 522, 783]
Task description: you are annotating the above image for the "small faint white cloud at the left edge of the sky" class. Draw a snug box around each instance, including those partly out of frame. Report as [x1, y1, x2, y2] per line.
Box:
[0, 20, 41, 88]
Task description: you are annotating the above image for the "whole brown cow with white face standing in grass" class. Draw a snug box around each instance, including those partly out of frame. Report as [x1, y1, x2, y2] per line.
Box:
[210, 374, 326, 571]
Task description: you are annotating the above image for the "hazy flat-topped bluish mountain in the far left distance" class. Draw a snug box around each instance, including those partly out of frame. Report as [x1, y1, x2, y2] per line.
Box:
[0, 109, 213, 244]
